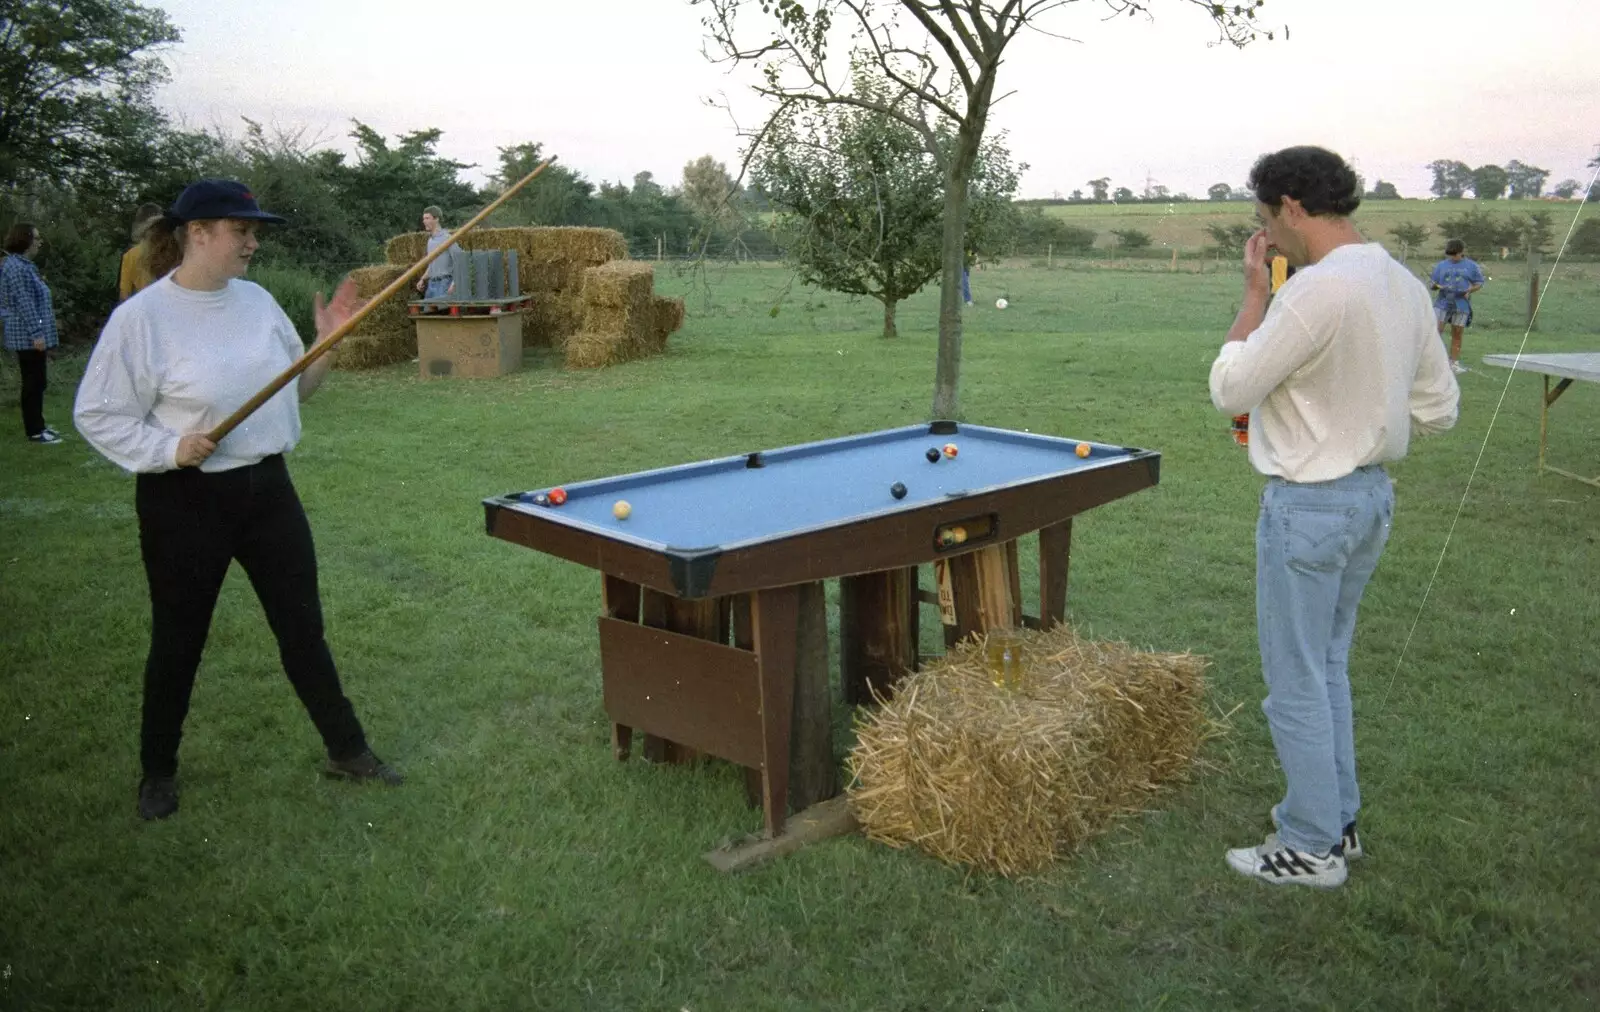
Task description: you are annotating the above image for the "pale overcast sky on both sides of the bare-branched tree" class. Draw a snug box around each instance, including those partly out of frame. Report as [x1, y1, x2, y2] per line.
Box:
[147, 0, 1600, 197]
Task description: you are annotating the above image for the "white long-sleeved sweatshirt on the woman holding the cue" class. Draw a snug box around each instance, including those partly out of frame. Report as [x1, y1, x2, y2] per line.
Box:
[72, 275, 306, 472]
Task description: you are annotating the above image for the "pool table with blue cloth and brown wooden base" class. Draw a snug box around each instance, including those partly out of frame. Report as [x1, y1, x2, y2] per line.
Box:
[483, 421, 1160, 834]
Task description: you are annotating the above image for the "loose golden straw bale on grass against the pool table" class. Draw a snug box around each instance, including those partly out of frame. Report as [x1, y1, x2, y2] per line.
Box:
[848, 624, 1211, 876]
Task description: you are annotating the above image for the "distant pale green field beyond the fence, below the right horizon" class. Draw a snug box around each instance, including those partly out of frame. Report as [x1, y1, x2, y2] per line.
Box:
[1045, 200, 1600, 256]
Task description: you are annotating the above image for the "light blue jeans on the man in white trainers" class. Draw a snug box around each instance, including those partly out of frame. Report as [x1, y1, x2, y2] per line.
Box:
[1256, 464, 1395, 853]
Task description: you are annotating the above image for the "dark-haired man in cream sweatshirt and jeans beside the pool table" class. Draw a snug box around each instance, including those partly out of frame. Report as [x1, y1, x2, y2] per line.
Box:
[1211, 147, 1459, 887]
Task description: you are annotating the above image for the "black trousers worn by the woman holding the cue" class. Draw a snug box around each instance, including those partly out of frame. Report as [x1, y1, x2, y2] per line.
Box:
[134, 456, 366, 777]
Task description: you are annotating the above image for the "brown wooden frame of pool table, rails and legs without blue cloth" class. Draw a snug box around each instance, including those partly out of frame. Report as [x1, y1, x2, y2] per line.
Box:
[485, 432, 1160, 836]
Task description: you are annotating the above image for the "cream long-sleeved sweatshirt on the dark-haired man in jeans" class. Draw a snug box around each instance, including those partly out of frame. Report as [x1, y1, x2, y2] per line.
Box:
[1211, 243, 1461, 482]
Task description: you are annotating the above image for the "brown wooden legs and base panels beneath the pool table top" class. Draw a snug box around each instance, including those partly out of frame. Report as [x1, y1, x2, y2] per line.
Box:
[582, 519, 1072, 836]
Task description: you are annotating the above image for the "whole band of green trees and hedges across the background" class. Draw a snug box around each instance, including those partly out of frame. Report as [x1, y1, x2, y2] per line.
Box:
[0, 0, 1600, 338]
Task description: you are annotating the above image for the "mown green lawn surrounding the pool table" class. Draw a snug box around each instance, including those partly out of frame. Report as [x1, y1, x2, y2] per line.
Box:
[0, 254, 1600, 1012]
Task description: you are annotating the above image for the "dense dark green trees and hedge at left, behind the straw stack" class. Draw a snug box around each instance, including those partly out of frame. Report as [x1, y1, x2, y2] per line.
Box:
[0, 0, 776, 339]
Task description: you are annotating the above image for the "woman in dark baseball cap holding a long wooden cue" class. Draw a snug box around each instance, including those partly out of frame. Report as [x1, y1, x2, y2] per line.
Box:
[74, 179, 402, 818]
